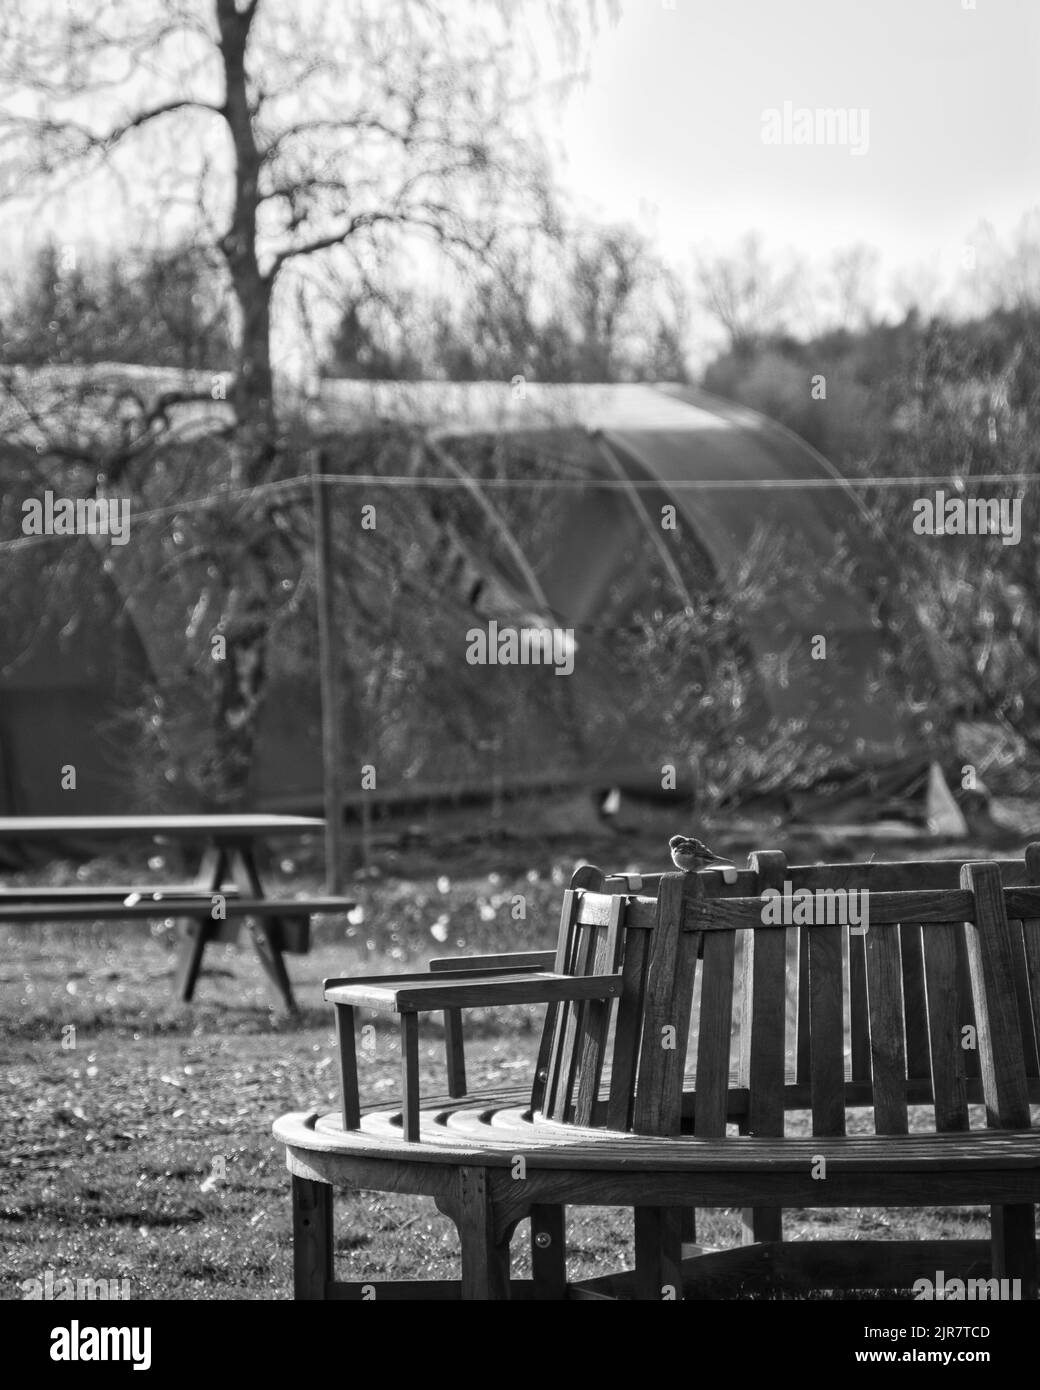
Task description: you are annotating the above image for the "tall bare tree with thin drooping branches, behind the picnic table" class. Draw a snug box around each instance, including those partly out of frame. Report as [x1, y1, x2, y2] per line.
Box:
[0, 0, 608, 799]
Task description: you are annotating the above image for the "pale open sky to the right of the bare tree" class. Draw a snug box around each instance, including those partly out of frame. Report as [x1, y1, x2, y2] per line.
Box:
[556, 0, 1040, 315]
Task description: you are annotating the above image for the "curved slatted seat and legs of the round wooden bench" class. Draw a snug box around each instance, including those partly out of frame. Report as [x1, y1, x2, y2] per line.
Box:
[274, 1102, 1040, 1300]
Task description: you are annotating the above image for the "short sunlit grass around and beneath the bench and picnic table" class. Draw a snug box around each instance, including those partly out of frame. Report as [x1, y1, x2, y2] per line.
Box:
[0, 811, 1022, 1300]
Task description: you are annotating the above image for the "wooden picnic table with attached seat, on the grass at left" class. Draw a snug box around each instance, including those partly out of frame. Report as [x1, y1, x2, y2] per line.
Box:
[0, 813, 355, 1011]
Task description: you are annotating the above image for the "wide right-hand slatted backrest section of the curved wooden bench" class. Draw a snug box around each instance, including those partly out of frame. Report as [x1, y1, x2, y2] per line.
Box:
[681, 855, 1040, 1137]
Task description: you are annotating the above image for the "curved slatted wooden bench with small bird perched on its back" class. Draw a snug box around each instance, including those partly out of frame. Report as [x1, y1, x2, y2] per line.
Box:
[275, 855, 1040, 1298]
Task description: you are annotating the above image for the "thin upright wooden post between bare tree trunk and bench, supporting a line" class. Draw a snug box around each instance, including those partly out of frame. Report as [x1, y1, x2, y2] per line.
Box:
[311, 450, 343, 894]
